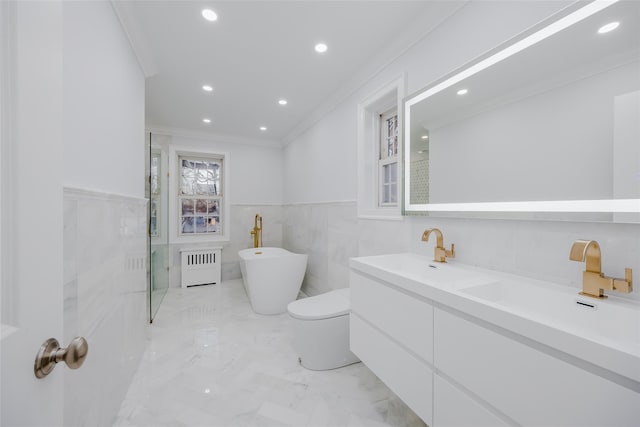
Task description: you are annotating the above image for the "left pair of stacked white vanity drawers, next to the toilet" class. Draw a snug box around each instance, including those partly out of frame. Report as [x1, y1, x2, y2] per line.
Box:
[350, 271, 433, 425]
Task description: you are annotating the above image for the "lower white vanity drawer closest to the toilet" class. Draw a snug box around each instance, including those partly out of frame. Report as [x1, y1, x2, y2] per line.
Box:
[350, 313, 433, 425]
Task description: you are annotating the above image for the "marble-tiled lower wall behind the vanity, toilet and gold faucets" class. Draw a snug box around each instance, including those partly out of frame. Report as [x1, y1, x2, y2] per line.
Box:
[283, 202, 640, 300]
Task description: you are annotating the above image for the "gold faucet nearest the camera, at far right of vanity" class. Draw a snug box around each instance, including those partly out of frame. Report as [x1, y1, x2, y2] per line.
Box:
[569, 240, 633, 298]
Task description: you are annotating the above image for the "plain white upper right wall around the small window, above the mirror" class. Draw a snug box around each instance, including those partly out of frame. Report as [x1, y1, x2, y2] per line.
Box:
[284, 1, 570, 203]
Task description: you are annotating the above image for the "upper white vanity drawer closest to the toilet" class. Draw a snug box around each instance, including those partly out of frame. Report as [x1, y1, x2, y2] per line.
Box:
[350, 271, 433, 363]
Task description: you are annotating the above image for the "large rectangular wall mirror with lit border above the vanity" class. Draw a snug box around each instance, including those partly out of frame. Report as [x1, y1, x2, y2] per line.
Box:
[403, 1, 640, 222]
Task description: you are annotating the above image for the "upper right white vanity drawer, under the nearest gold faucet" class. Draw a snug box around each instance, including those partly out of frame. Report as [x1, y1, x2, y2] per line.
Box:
[434, 309, 640, 427]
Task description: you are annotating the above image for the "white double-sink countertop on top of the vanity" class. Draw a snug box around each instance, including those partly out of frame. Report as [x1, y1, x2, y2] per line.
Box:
[349, 253, 640, 389]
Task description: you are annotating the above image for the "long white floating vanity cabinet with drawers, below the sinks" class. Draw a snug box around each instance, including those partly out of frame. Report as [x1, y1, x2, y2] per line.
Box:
[350, 259, 640, 427]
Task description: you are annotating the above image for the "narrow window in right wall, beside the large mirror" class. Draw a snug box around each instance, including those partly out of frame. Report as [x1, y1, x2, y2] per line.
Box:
[378, 108, 398, 207]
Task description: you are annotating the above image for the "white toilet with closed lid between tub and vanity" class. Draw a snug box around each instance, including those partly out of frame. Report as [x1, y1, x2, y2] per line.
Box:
[287, 288, 360, 371]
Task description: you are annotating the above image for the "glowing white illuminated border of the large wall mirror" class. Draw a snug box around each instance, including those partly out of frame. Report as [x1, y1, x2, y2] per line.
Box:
[402, 0, 640, 222]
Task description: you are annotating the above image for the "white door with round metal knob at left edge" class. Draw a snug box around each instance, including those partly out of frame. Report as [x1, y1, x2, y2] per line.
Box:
[0, 1, 68, 426]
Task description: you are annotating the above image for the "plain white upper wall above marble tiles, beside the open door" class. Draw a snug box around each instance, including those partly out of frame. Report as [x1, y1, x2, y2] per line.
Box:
[63, 1, 144, 197]
